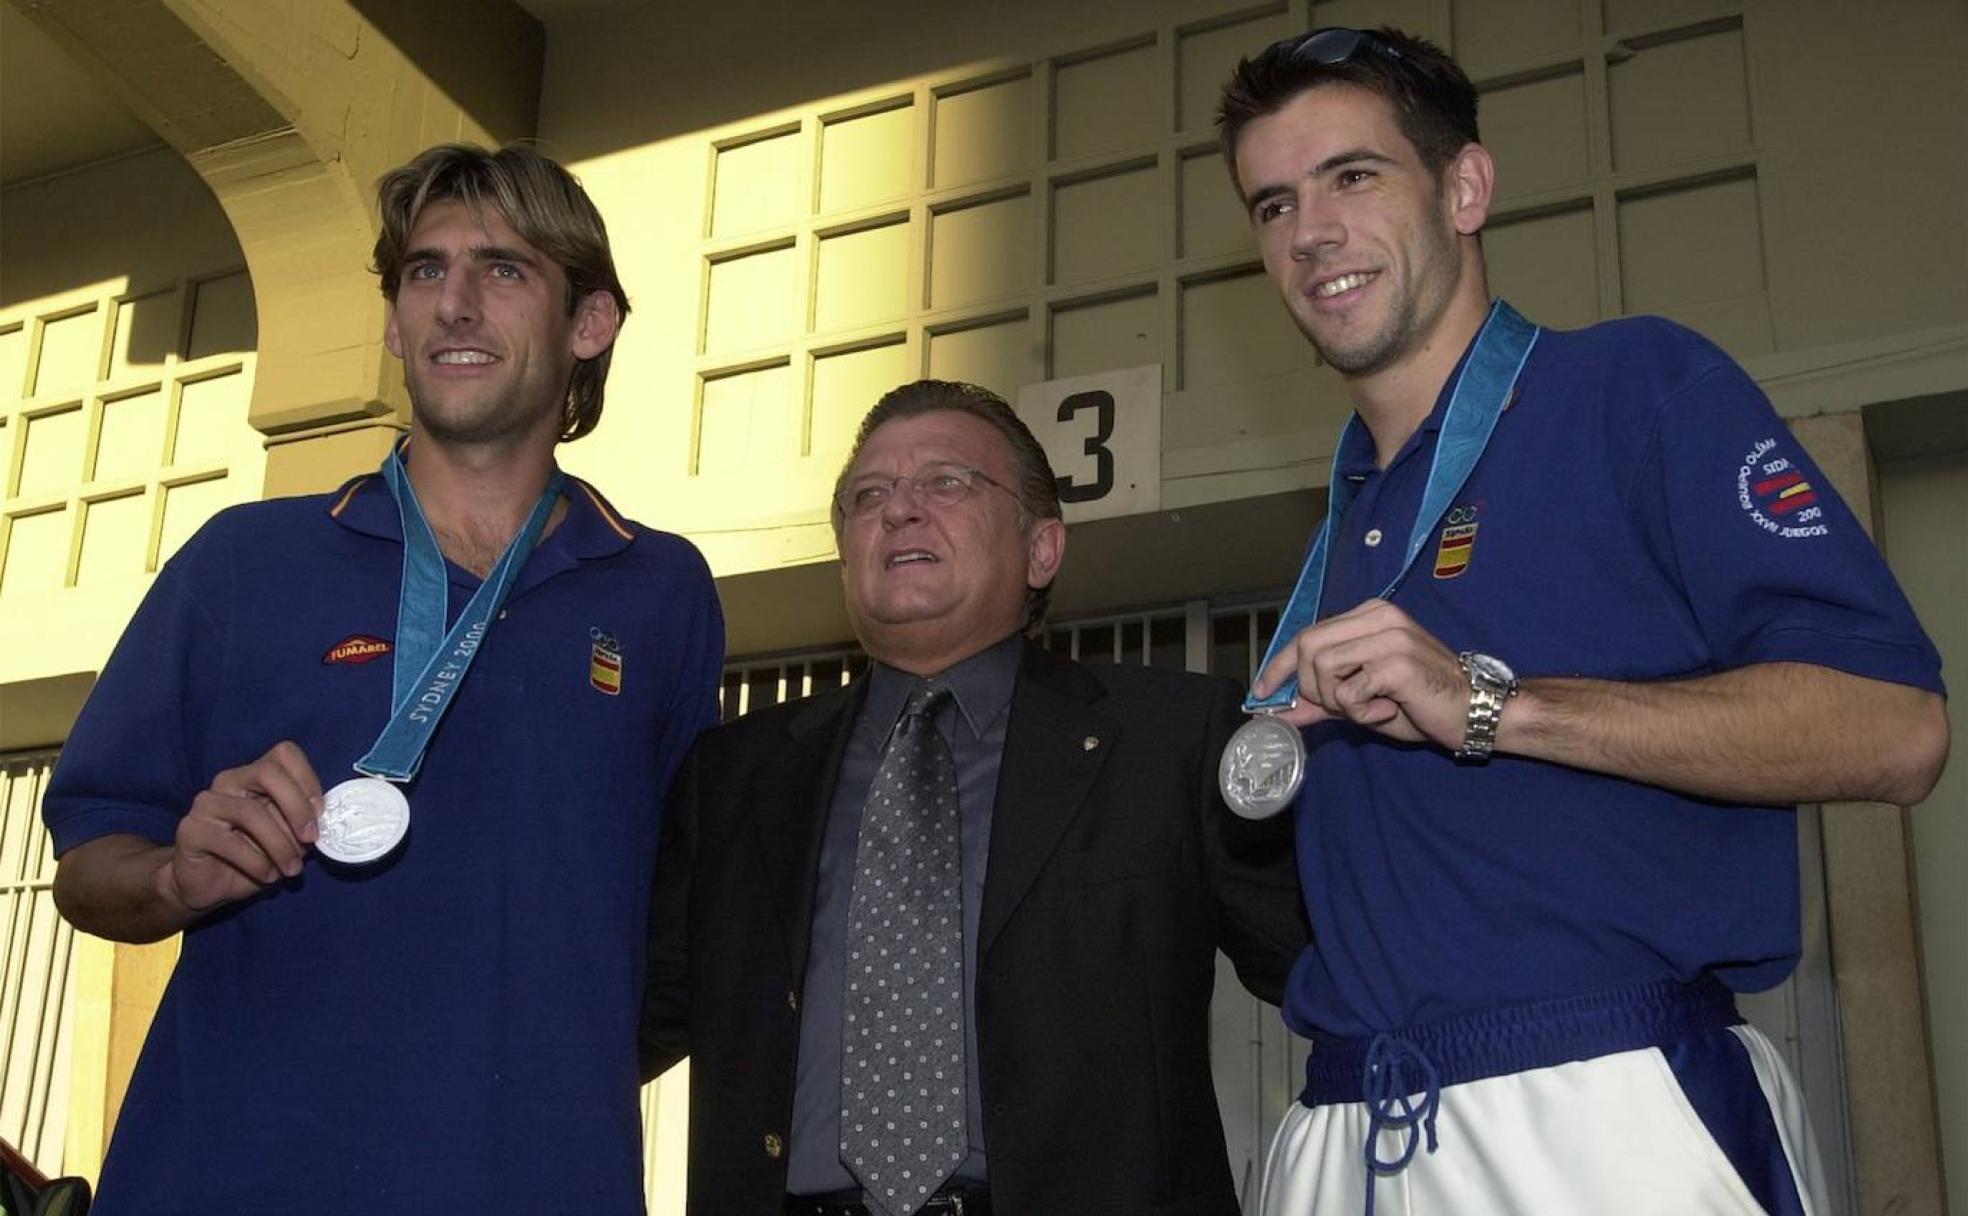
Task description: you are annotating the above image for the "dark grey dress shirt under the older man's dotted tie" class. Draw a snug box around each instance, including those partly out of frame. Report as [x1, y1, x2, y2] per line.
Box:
[785, 634, 1025, 1194]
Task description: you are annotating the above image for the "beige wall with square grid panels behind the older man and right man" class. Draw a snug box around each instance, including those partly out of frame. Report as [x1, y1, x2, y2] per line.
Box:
[539, 0, 1968, 649]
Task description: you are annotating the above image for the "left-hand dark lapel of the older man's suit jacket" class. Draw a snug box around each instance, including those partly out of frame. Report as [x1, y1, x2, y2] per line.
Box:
[752, 681, 866, 984]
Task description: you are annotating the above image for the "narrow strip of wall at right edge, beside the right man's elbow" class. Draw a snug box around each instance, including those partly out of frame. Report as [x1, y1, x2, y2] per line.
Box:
[1879, 452, 1968, 1212]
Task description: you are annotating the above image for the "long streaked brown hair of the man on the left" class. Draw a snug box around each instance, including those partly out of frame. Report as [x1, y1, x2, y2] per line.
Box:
[370, 144, 628, 443]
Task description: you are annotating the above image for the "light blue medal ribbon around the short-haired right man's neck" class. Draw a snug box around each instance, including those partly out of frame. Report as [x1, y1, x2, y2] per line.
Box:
[1244, 299, 1539, 714]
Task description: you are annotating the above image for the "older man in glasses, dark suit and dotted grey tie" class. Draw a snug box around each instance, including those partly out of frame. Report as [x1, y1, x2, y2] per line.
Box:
[644, 380, 1307, 1216]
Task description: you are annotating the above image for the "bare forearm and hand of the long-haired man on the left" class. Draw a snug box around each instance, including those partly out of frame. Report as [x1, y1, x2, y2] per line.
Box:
[55, 742, 321, 942]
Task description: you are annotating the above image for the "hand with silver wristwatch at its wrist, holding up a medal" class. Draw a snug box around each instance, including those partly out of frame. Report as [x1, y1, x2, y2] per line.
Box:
[1252, 600, 1470, 752]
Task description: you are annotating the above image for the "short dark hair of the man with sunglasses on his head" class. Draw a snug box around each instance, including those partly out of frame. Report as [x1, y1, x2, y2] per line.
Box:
[1216, 26, 1482, 191]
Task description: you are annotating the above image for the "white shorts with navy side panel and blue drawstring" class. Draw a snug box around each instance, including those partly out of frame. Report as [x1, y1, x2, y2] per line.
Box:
[1260, 1025, 1830, 1216]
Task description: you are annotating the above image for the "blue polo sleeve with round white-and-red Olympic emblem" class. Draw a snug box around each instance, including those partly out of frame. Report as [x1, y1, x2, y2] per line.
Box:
[1630, 334, 1942, 693]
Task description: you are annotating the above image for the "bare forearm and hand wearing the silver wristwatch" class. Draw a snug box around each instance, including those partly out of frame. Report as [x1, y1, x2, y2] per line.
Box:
[1258, 600, 1948, 807]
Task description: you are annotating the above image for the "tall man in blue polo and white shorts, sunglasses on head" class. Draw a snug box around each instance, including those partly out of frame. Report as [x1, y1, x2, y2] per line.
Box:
[1222, 21, 1946, 1216]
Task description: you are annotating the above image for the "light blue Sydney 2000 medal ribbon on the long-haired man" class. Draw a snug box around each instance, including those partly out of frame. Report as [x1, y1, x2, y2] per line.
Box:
[356, 447, 567, 781]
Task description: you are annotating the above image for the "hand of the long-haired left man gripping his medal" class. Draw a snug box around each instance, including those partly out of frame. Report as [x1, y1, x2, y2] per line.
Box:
[157, 742, 321, 915]
